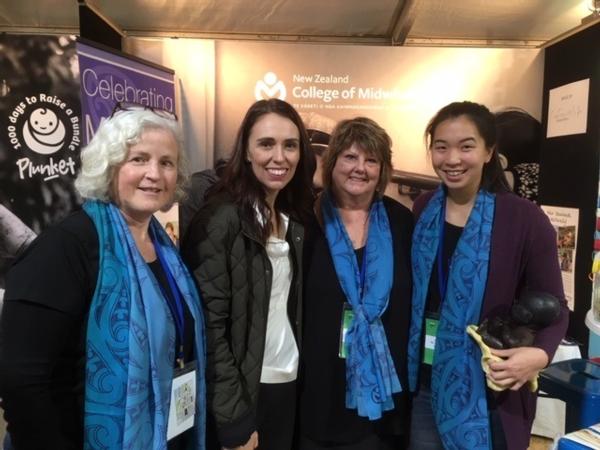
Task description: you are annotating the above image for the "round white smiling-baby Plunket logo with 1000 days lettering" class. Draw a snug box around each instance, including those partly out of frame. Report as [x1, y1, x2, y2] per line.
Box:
[7, 94, 81, 180]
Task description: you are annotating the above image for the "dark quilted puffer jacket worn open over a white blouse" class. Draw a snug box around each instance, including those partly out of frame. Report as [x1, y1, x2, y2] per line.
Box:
[182, 194, 304, 447]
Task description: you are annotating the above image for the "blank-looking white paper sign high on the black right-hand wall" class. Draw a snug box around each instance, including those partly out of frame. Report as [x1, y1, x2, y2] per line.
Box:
[546, 78, 590, 138]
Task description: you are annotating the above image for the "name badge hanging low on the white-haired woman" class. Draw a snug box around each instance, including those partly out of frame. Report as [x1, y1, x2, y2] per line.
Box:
[167, 361, 196, 440]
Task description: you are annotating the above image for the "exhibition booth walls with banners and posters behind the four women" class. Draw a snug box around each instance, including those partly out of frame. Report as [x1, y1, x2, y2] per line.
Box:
[0, 5, 600, 448]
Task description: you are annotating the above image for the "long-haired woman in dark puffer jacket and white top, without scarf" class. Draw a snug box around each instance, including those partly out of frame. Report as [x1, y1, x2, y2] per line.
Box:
[182, 99, 314, 450]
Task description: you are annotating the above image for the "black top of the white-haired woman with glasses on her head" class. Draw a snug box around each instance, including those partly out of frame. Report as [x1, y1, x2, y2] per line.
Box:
[0, 211, 194, 450]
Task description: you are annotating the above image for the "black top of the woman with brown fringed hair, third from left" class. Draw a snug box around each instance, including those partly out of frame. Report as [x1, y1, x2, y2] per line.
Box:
[299, 198, 413, 444]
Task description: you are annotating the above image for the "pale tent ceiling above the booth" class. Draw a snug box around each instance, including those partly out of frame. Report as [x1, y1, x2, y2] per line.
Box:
[0, 0, 598, 47]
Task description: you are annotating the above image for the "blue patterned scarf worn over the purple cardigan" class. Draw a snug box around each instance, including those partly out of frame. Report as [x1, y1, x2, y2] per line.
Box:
[408, 187, 495, 450]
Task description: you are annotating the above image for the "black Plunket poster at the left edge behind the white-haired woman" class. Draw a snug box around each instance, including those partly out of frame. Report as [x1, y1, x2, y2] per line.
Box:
[0, 34, 81, 299]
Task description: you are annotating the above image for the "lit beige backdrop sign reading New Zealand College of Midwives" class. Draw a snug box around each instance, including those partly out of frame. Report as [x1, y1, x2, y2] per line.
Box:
[212, 41, 543, 175]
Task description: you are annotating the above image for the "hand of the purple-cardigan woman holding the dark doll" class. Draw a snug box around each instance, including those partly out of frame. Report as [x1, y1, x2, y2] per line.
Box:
[487, 347, 548, 391]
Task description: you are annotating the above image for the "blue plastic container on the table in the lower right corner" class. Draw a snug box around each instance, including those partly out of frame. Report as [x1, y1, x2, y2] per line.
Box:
[540, 359, 600, 433]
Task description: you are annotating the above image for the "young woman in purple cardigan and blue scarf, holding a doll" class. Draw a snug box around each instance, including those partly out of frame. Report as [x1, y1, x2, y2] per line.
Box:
[409, 102, 568, 450]
